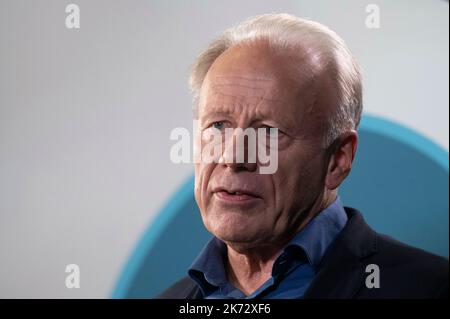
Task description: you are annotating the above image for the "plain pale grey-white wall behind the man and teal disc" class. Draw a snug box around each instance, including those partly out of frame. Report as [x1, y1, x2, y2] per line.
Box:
[0, 0, 449, 298]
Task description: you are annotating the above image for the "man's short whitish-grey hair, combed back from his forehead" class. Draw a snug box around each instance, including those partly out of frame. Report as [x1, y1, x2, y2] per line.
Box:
[189, 13, 362, 146]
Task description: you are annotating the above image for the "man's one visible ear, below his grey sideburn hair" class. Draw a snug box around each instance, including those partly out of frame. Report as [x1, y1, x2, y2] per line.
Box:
[325, 130, 358, 190]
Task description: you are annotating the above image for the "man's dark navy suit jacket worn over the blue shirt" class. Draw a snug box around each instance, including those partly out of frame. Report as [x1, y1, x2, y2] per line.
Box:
[157, 207, 448, 299]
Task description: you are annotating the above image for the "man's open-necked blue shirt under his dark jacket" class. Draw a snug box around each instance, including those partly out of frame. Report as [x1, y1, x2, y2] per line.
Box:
[188, 197, 347, 299]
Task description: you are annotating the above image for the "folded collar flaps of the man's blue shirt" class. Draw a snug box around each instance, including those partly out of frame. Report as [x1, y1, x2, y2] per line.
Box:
[188, 196, 347, 293]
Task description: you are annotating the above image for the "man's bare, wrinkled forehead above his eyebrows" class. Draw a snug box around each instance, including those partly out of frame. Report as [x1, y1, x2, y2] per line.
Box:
[199, 44, 326, 126]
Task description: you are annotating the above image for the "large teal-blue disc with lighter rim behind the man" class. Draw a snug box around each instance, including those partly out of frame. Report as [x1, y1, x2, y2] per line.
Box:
[112, 115, 449, 298]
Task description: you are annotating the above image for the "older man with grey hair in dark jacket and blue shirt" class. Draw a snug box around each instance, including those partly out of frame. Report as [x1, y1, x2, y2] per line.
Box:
[159, 14, 448, 298]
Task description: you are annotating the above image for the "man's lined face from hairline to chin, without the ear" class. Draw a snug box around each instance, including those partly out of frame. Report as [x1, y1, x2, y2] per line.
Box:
[195, 43, 333, 248]
